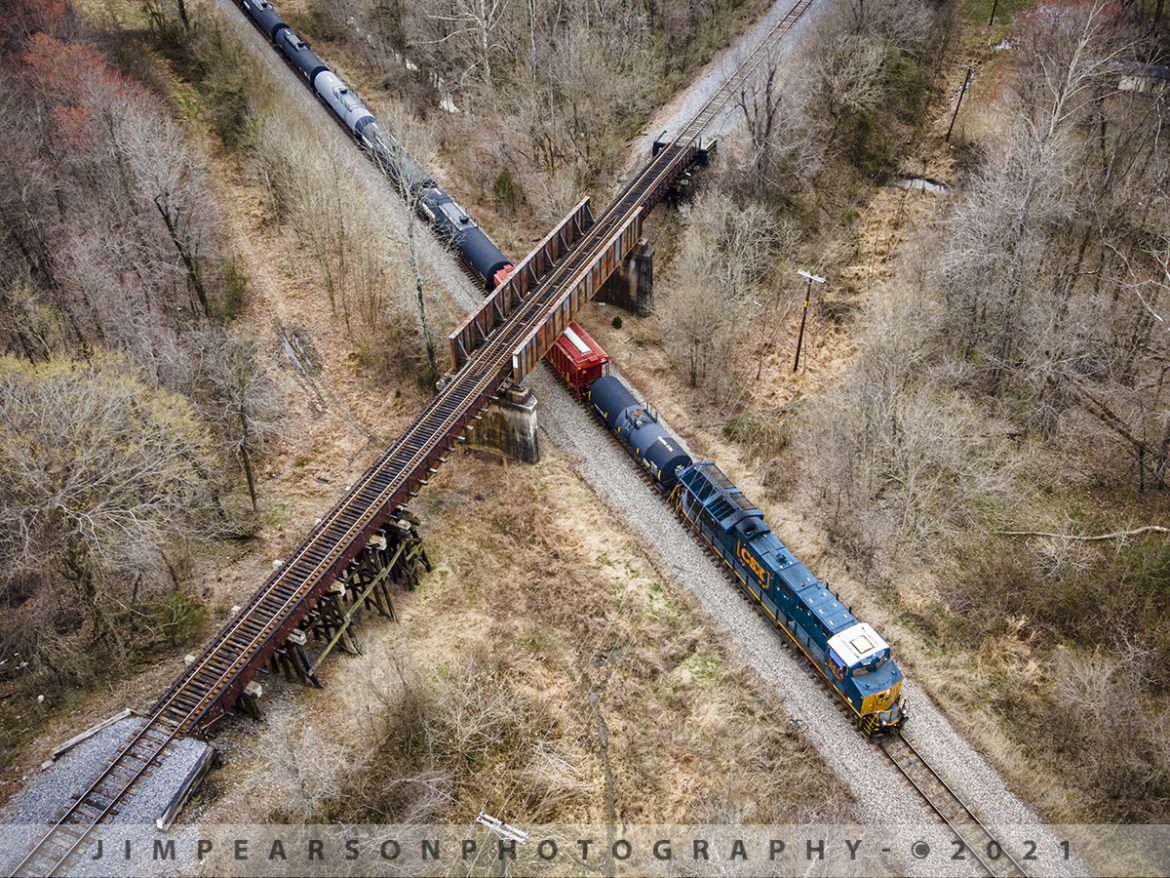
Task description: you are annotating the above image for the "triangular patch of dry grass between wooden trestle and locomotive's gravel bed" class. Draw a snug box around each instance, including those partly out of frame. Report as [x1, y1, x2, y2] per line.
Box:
[209, 454, 851, 823]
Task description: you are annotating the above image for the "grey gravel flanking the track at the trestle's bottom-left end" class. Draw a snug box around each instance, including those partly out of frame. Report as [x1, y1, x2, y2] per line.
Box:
[0, 716, 211, 874]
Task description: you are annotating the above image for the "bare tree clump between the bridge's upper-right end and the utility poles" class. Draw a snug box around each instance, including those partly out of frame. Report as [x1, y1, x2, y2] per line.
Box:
[641, 2, 948, 402]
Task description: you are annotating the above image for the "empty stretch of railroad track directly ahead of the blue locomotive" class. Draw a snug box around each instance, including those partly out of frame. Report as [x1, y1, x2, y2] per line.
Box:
[878, 735, 1027, 878]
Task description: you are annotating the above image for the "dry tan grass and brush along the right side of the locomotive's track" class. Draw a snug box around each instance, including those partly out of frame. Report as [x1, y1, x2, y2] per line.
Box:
[585, 41, 1170, 822]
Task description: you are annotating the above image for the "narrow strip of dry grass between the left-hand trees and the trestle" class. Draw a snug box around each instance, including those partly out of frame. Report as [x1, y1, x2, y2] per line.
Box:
[0, 4, 437, 801]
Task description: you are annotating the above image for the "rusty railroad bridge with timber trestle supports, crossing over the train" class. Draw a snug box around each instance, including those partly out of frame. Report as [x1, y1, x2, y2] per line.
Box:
[6, 0, 812, 876]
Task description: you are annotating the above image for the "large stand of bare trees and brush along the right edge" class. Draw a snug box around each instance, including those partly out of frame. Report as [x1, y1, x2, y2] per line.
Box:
[808, 4, 1170, 819]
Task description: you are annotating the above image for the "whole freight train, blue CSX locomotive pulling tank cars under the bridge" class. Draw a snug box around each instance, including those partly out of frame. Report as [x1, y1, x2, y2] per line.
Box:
[238, 0, 907, 735]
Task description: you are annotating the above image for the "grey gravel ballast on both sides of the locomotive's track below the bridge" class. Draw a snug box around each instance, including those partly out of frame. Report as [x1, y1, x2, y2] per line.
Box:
[528, 368, 1069, 876]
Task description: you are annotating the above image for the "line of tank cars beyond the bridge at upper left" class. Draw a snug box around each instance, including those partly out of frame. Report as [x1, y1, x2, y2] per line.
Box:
[238, 0, 512, 290]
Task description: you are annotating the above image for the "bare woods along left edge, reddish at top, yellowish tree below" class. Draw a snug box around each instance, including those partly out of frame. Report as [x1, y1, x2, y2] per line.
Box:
[0, 0, 270, 692]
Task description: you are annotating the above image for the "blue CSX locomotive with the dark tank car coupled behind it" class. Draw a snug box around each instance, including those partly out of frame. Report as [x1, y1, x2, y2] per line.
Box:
[589, 376, 907, 735]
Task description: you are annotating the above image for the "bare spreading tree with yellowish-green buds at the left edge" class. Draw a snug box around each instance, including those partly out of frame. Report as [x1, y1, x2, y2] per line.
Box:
[0, 355, 214, 678]
